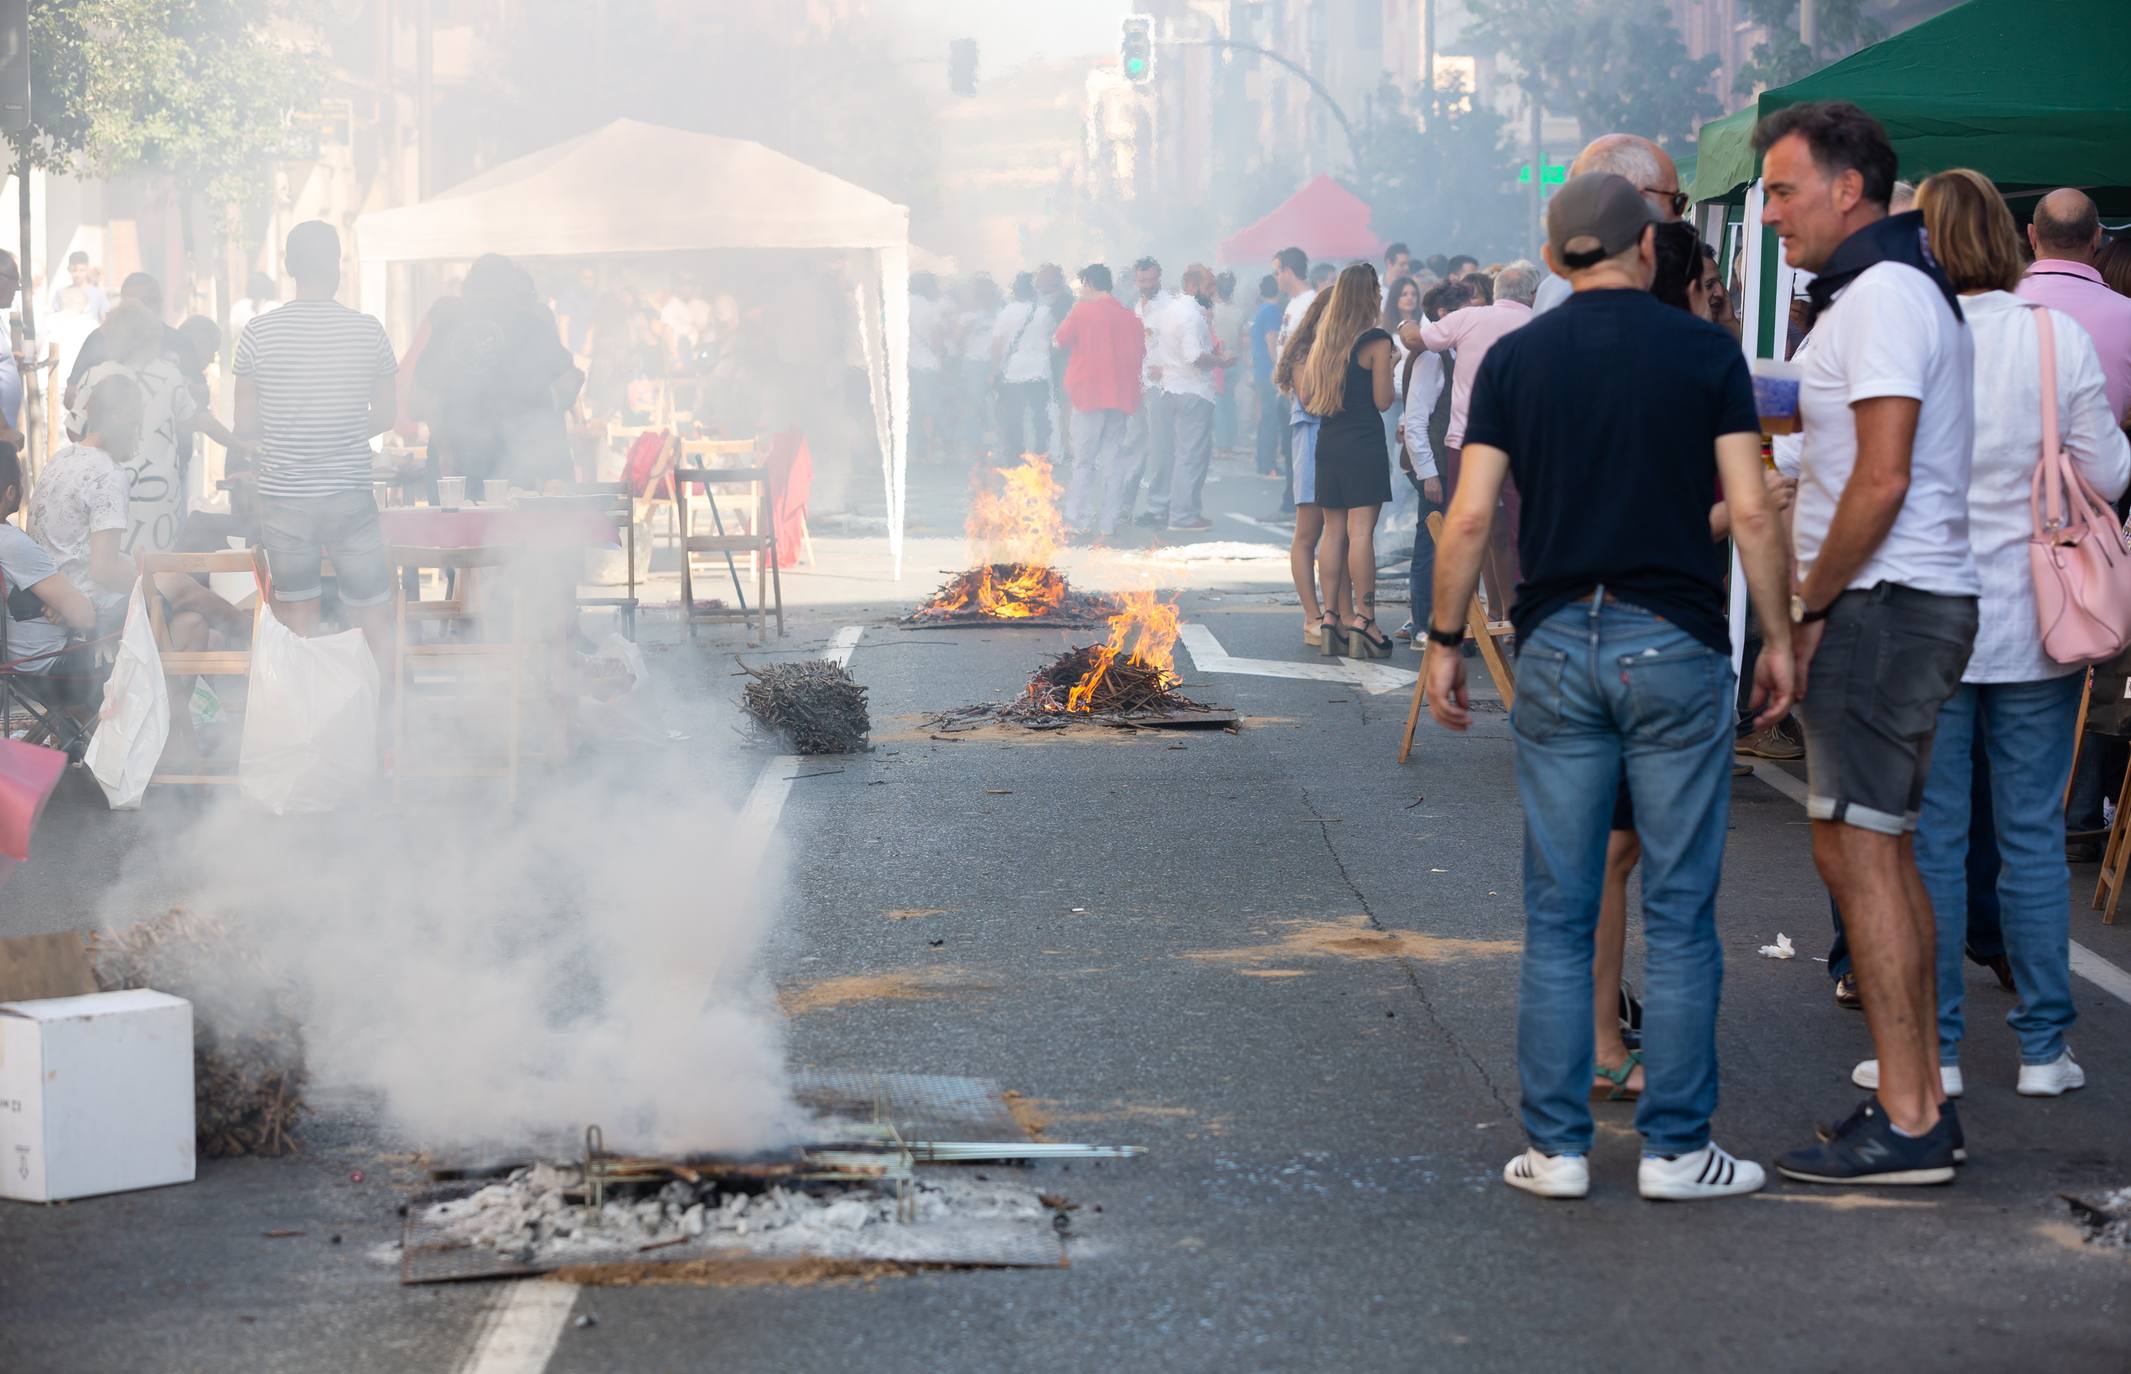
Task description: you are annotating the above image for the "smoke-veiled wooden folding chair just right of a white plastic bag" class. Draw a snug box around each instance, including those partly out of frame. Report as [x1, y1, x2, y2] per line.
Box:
[392, 545, 524, 801]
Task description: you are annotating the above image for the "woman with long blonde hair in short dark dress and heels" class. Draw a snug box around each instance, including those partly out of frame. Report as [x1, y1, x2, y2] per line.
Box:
[1300, 262, 1396, 658]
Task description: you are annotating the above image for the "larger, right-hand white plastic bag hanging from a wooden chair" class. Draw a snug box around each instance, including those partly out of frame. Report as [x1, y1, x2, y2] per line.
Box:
[237, 609, 377, 816]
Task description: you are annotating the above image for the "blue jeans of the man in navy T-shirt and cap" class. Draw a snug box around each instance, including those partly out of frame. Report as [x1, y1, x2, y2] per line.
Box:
[1511, 599, 1735, 1155]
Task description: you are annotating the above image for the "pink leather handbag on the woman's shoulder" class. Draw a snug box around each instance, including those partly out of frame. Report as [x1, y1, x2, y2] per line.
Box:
[2027, 309, 2131, 665]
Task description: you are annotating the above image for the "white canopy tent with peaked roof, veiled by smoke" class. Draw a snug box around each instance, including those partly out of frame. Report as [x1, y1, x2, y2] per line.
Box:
[356, 119, 910, 577]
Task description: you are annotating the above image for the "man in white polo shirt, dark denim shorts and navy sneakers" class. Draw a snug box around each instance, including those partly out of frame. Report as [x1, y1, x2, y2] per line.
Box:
[1754, 102, 1982, 1184]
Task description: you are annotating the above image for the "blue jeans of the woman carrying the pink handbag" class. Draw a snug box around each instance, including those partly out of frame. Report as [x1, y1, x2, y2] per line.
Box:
[1916, 673, 2082, 1063]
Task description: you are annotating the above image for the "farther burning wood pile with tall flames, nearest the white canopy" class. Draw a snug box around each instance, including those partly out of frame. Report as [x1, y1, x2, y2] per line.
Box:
[904, 454, 1117, 626]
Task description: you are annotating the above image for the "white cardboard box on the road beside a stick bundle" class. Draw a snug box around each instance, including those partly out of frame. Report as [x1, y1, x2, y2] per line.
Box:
[0, 988, 192, 1201]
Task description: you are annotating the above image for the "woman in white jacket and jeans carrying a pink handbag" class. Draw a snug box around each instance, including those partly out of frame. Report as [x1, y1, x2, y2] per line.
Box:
[1900, 170, 2131, 1097]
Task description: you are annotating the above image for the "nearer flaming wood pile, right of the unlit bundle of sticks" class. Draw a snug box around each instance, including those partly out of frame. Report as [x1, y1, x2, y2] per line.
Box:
[933, 592, 1234, 733]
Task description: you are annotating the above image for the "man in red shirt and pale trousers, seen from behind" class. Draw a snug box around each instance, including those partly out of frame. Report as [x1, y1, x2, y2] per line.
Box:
[1051, 262, 1146, 537]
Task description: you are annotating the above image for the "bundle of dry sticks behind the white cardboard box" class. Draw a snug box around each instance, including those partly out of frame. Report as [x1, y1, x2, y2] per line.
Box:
[90, 907, 307, 1159]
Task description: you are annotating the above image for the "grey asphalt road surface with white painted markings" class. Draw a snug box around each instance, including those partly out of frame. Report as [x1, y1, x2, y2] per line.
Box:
[0, 460, 2131, 1374]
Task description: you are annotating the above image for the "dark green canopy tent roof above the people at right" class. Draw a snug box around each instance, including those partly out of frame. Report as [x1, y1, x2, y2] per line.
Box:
[1690, 0, 2131, 215]
